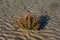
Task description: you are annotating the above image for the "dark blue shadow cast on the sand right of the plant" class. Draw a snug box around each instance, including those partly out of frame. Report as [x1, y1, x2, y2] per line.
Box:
[38, 15, 50, 30]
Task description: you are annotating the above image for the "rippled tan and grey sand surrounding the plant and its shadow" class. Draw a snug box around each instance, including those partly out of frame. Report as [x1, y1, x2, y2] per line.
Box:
[0, 0, 60, 40]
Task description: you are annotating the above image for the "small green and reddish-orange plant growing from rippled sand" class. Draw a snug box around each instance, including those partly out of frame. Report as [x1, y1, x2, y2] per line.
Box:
[14, 12, 39, 30]
